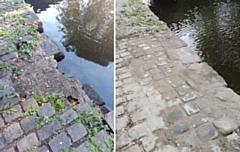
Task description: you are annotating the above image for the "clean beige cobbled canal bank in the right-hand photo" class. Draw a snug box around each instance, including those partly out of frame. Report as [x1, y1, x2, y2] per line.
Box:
[116, 0, 240, 152]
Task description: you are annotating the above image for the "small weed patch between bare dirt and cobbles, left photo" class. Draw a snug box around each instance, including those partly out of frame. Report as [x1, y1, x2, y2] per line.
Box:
[32, 92, 64, 112]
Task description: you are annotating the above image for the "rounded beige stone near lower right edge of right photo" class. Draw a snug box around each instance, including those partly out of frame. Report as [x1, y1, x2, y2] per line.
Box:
[213, 116, 238, 135]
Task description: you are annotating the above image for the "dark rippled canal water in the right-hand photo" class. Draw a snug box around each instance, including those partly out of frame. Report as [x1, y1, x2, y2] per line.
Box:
[150, 0, 240, 94]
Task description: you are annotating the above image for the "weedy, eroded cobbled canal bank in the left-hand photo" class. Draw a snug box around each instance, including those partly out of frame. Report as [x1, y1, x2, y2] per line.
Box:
[0, 1, 114, 152]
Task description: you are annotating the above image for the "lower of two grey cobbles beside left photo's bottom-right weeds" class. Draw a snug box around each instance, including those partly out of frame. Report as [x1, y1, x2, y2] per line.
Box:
[67, 123, 87, 142]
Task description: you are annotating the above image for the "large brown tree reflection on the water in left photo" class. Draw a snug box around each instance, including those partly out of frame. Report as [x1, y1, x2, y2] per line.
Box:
[57, 0, 113, 66]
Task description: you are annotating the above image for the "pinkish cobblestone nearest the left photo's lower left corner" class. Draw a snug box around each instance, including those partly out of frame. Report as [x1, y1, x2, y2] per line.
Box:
[3, 123, 23, 144]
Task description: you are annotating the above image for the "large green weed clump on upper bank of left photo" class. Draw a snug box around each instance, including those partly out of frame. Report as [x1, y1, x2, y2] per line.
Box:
[0, 3, 38, 60]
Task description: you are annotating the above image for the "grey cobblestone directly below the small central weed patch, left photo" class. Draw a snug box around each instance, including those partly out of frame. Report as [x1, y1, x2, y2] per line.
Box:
[37, 103, 56, 117]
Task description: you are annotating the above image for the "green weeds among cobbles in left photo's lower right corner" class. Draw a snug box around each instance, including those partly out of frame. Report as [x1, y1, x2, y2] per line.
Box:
[74, 108, 114, 152]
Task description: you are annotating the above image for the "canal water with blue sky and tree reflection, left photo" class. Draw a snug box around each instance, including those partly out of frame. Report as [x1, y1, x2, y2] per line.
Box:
[25, 0, 114, 109]
